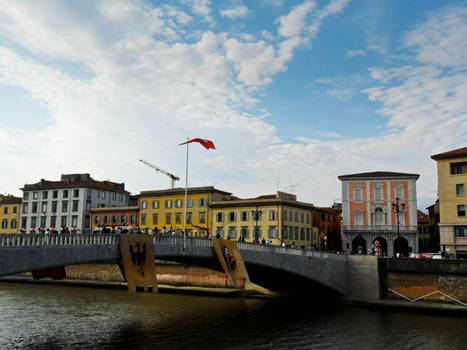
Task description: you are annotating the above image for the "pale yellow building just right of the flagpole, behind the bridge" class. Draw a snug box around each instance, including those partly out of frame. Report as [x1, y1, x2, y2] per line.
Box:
[210, 192, 315, 247]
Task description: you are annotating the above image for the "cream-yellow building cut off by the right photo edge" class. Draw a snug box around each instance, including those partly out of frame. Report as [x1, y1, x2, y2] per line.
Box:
[431, 147, 467, 258]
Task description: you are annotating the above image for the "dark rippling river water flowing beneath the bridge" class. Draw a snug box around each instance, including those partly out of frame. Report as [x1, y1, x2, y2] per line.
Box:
[0, 282, 467, 350]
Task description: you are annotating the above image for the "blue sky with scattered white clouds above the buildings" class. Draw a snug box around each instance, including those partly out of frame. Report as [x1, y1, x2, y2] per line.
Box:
[0, 0, 467, 209]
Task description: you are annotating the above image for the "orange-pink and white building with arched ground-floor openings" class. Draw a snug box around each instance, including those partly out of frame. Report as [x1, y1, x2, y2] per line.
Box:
[338, 171, 419, 256]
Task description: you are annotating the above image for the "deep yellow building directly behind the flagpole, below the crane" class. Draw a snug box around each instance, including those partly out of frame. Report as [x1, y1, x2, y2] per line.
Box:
[138, 186, 231, 235]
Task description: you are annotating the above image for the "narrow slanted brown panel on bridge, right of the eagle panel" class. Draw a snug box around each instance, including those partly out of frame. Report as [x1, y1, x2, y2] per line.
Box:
[212, 239, 250, 288]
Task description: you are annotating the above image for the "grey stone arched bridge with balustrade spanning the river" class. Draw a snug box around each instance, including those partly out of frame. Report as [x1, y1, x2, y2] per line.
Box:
[0, 234, 380, 301]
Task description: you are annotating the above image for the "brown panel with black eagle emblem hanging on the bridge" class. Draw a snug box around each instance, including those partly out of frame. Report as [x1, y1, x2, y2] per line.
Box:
[119, 234, 157, 293]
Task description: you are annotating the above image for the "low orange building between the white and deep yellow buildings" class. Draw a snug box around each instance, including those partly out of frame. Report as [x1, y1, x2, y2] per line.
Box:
[91, 205, 139, 230]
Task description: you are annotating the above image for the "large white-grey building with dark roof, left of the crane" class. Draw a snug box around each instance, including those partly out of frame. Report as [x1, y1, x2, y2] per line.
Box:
[21, 174, 129, 232]
